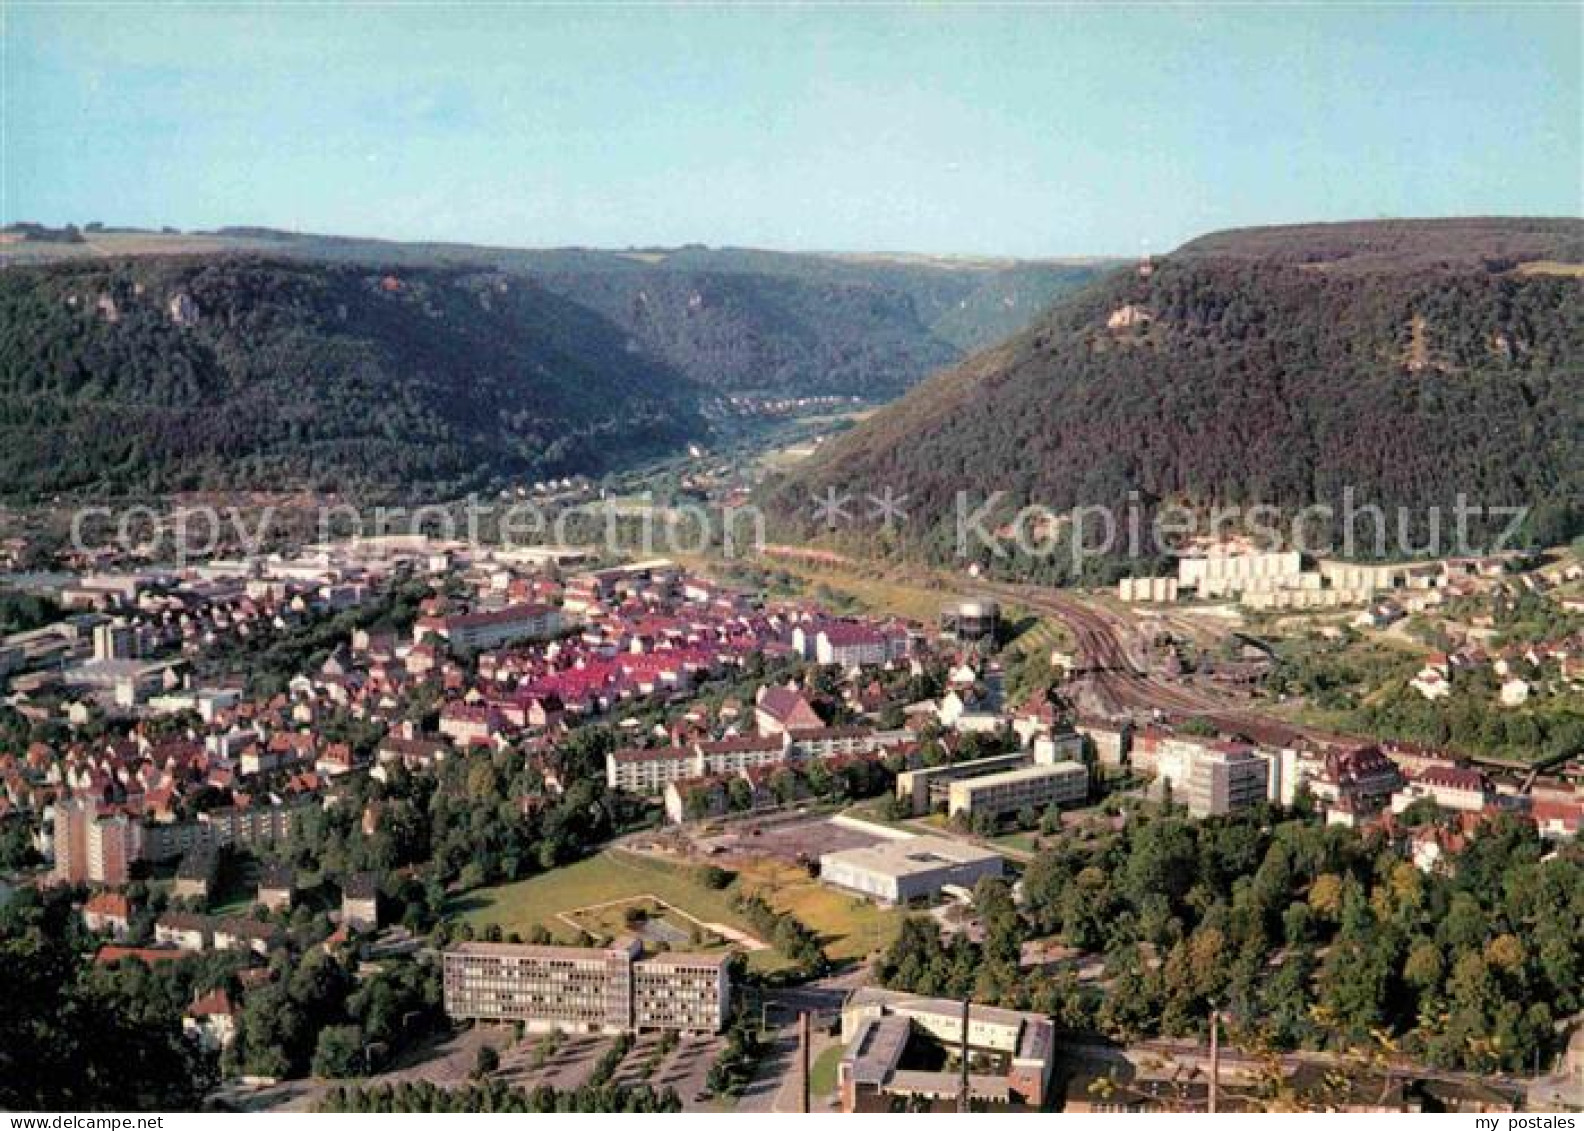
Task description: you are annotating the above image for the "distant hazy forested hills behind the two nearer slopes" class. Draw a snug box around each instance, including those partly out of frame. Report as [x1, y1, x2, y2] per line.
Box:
[0, 225, 1101, 401]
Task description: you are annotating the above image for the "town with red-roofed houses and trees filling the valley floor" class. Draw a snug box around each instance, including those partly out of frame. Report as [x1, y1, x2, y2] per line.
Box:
[0, 537, 1584, 1110]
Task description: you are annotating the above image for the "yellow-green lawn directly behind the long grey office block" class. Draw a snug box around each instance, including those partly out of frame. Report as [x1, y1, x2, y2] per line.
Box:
[451, 849, 901, 971]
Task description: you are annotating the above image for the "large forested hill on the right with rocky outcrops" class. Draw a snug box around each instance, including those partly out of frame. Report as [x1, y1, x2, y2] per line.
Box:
[771, 220, 1584, 553]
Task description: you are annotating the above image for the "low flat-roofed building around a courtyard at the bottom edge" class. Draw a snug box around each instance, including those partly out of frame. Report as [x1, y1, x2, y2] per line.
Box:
[836, 987, 1055, 1112]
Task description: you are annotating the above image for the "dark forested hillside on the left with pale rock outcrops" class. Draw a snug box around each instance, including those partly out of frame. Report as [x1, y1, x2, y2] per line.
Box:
[0, 257, 705, 496]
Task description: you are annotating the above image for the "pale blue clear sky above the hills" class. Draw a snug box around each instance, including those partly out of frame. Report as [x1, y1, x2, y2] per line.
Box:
[0, 0, 1584, 257]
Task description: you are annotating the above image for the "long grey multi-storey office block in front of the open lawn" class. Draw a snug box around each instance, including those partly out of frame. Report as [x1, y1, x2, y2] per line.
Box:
[445, 939, 732, 1033]
